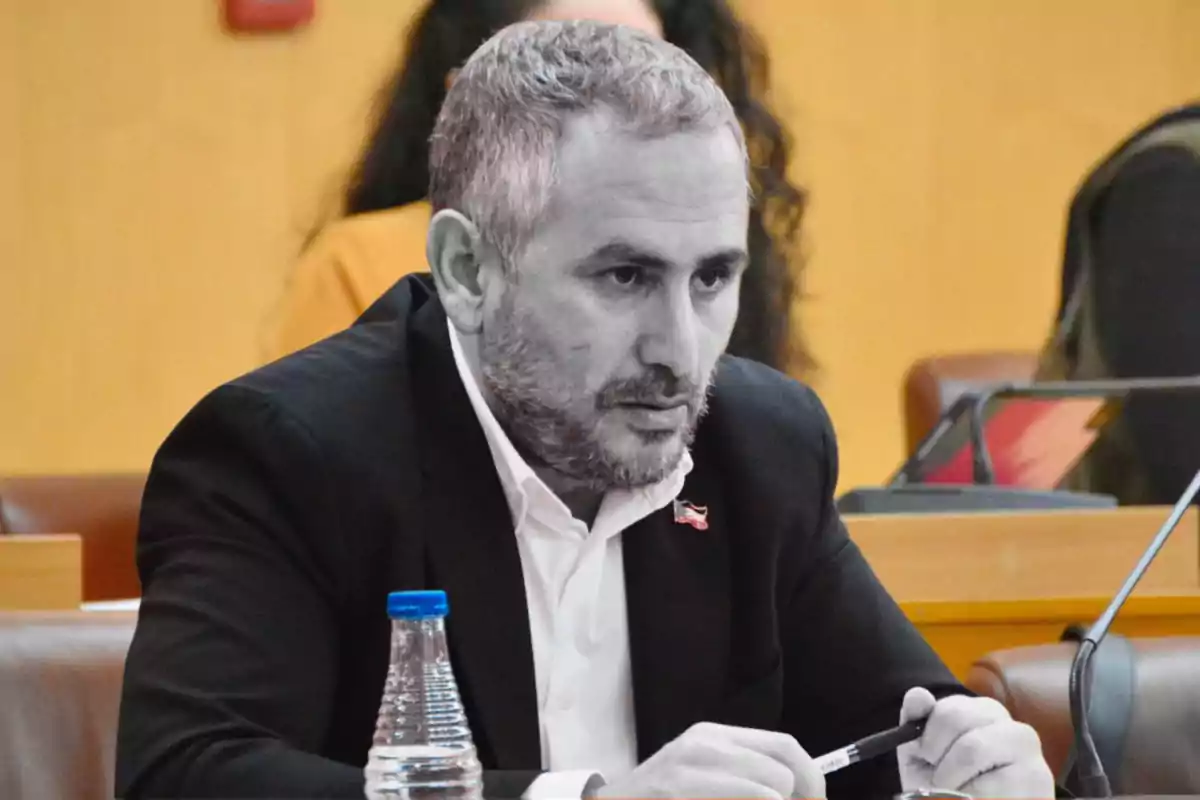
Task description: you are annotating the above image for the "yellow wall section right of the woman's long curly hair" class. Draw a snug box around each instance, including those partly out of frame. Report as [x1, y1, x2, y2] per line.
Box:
[744, 0, 1200, 488]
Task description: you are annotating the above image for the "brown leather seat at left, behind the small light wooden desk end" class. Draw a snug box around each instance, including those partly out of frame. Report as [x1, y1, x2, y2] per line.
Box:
[0, 474, 146, 601]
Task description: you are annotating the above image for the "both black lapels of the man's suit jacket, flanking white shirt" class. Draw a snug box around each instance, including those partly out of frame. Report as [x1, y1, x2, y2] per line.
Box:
[397, 280, 731, 770]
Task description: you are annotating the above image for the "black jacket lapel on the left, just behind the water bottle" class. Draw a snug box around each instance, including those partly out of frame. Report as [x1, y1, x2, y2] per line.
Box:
[409, 301, 541, 769]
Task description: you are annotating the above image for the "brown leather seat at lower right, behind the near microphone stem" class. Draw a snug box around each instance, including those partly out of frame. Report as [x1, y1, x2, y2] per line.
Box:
[966, 637, 1200, 795]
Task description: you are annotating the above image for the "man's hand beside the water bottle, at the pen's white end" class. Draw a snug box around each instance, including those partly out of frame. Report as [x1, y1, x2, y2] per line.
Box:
[593, 722, 824, 800]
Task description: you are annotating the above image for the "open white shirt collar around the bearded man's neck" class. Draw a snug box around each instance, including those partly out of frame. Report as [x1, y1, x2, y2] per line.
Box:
[446, 318, 692, 531]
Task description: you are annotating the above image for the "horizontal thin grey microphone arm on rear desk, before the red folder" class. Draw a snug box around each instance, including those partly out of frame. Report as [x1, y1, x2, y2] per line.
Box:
[967, 375, 1200, 486]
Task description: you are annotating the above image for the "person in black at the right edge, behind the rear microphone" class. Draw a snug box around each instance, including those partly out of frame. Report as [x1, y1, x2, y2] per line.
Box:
[1036, 101, 1200, 505]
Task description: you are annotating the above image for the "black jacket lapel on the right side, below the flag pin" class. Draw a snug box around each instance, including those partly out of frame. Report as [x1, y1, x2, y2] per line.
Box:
[622, 451, 730, 760]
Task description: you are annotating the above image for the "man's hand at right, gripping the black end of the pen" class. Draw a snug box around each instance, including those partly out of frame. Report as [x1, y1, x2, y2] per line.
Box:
[896, 687, 1055, 798]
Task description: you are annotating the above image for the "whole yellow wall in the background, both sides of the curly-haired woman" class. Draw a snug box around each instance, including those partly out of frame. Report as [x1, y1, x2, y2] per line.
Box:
[0, 0, 1200, 486]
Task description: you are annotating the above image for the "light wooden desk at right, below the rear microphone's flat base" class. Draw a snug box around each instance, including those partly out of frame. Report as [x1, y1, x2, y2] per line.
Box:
[846, 506, 1200, 678]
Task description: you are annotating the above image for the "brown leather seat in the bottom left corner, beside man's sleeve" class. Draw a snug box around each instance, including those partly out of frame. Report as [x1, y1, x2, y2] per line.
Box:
[0, 612, 137, 800]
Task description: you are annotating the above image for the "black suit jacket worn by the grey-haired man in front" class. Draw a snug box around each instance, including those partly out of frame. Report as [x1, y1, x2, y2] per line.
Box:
[116, 276, 961, 798]
